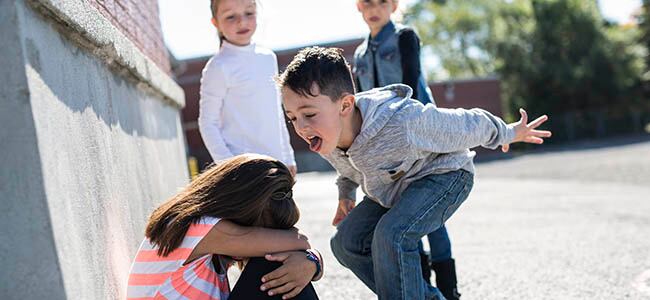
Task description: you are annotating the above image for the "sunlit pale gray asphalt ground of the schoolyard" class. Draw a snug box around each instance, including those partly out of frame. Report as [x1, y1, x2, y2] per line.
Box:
[294, 136, 650, 299]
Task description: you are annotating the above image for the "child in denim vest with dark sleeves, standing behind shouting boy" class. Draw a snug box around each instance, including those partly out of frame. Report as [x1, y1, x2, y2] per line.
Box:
[348, 0, 450, 300]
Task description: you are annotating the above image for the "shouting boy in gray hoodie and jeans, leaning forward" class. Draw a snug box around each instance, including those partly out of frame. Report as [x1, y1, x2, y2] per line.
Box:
[278, 47, 551, 299]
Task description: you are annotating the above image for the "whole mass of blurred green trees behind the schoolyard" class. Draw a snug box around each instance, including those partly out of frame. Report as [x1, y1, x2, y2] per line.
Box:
[406, 0, 650, 131]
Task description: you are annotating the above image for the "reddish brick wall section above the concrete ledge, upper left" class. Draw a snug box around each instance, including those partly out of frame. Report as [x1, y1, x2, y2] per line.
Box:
[88, 0, 171, 74]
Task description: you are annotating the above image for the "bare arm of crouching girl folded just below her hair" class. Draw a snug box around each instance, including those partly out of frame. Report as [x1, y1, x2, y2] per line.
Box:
[193, 220, 310, 257]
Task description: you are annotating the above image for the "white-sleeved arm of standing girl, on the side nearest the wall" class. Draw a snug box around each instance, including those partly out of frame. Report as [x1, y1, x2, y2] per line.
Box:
[199, 60, 233, 161]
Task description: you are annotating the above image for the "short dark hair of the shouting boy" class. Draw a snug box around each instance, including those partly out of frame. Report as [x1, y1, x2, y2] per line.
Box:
[277, 47, 356, 101]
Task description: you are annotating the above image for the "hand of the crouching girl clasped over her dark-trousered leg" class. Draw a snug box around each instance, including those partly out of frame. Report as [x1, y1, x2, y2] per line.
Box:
[260, 251, 316, 299]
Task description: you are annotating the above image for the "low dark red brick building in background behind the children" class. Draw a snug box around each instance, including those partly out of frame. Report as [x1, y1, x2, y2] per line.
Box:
[175, 39, 502, 171]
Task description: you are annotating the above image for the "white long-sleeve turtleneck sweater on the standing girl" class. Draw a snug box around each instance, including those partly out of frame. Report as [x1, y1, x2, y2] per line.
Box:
[199, 41, 296, 166]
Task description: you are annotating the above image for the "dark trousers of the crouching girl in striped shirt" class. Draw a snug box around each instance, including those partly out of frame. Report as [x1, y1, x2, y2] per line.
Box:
[228, 257, 318, 300]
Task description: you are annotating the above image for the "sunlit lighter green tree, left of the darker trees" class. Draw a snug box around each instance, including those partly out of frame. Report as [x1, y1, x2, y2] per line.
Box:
[405, 0, 534, 120]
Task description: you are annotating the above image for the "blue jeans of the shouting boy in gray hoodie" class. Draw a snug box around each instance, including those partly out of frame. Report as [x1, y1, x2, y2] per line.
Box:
[331, 170, 474, 300]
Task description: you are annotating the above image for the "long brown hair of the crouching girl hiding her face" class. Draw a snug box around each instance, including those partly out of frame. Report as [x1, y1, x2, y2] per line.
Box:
[145, 154, 300, 256]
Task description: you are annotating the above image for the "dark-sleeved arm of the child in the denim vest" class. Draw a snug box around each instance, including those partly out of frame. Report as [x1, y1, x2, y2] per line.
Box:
[398, 28, 422, 100]
